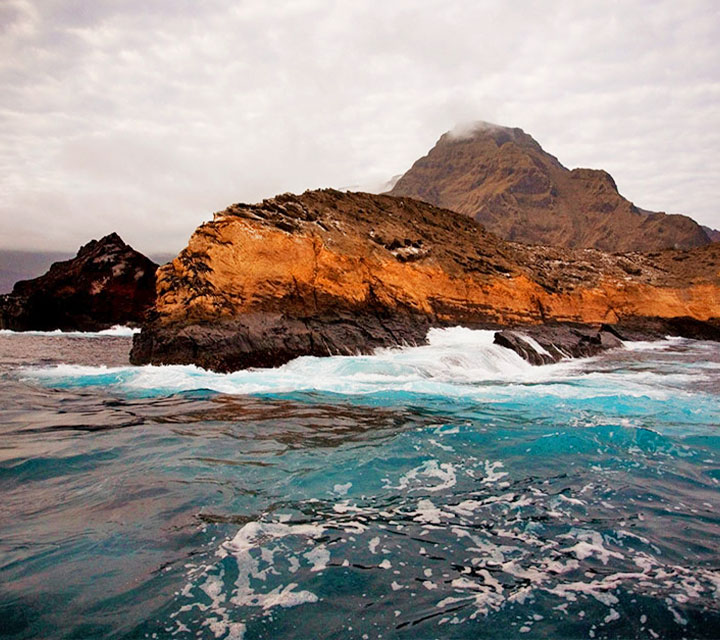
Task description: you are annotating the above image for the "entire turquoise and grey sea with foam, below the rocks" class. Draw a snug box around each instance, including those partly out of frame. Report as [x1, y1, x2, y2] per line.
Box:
[0, 328, 720, 640]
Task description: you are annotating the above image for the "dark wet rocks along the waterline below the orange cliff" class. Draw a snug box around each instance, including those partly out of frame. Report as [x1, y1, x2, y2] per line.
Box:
[131, 313, 720, 372]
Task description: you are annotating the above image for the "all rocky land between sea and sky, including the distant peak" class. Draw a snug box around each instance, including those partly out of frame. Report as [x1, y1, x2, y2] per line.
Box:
[5, 123, 720, 372]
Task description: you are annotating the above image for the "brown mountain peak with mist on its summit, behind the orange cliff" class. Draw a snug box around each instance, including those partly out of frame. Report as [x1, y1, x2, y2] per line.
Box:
[389, 124, 710, 251]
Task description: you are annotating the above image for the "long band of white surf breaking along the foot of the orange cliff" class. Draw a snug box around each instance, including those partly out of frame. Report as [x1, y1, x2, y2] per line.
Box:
[22, 327, 704, 402]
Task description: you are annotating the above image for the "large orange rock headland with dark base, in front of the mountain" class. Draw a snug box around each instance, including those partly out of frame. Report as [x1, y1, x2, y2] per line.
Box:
[131, 190, 720, 371]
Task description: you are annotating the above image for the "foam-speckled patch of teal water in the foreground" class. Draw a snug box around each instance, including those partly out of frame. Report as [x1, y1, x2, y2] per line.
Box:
[163, 418, 720, 637]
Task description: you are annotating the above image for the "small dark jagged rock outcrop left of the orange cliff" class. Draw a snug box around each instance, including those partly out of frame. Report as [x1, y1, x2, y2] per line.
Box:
[0, 233, 157, 331]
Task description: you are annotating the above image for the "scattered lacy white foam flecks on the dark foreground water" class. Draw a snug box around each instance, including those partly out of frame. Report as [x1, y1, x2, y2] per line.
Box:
[167, 444, 720, 632]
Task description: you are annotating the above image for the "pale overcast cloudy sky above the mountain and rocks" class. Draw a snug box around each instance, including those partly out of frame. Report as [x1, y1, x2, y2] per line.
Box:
[0, 0, 720, 252]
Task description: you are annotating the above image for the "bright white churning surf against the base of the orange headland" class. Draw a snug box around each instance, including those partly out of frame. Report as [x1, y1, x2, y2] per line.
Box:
[23, 328, 576, 395]
